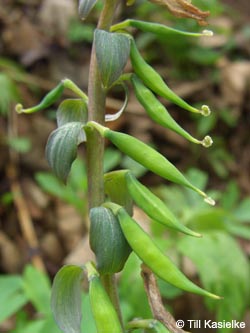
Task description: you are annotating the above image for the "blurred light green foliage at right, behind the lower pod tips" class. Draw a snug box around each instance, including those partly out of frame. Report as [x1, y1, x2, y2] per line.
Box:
[153, 169, 250, 332]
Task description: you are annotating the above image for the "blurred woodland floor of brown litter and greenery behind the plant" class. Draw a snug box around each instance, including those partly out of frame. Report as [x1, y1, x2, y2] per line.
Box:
[0, 0, 250, 333]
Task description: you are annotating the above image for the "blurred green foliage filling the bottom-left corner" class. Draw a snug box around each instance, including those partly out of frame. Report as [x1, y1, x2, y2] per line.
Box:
[0, 265, 60, 333]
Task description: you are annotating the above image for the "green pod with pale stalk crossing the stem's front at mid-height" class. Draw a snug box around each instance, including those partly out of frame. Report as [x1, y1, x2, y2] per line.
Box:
[86, 121, 215, 205]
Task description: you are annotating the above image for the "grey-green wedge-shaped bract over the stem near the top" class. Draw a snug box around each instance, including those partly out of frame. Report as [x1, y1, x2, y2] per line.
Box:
[94, 29, 130, 89]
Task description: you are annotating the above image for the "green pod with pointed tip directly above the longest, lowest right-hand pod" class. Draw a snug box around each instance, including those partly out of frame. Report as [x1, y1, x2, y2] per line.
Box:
[125, 172, 201, 237]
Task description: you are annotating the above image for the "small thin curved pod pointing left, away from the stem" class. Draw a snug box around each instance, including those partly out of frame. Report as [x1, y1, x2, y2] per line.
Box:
[16, 82, 64, 113]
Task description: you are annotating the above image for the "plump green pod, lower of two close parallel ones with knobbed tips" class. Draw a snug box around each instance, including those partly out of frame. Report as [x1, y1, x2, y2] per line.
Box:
[131, 75, 212, 147]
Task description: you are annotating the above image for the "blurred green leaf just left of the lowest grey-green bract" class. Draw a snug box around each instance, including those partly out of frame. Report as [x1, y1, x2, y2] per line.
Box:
[22, 265, 51, 314]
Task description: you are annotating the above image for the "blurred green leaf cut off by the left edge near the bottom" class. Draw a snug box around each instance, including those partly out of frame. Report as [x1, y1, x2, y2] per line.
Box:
[0, 275, 28, 322]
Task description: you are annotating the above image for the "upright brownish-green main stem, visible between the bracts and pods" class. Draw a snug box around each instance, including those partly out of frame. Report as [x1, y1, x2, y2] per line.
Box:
[86, 0, 122, 324]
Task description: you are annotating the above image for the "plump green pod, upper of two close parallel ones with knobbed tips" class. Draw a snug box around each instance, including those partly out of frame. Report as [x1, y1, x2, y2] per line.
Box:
[130, 39, 210, 116]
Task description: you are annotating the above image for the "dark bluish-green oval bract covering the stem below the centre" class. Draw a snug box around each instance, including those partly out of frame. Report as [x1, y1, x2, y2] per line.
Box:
[90, 207, 131, 274]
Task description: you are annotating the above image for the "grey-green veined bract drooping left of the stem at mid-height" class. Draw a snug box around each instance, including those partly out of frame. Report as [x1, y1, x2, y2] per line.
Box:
[46, 122, 83, 181]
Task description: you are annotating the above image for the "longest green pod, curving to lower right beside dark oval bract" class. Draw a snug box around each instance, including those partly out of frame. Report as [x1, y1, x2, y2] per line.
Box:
[117, 208, 220, 299]
